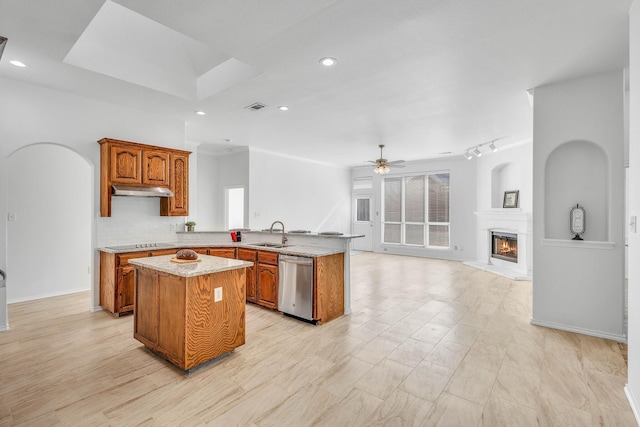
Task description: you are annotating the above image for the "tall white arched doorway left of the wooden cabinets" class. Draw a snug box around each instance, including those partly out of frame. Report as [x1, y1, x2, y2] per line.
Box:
[6, 143, 93, 304]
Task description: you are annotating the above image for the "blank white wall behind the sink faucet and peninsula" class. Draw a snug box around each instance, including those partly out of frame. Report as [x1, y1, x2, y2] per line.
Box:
[248, 149, 351, 234]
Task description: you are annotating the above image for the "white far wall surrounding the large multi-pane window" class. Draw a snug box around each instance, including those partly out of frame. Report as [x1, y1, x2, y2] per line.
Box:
[353, 156, 477, 261]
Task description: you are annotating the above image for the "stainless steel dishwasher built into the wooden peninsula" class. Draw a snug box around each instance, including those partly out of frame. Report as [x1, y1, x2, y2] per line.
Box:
[278, 255, 313, 322]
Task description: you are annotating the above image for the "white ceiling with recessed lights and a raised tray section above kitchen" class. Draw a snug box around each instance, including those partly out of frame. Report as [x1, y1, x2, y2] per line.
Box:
[0, 0, 632, 166]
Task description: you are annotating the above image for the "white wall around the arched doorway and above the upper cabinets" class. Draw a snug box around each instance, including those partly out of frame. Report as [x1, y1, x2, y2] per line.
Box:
[0, 78, 185, 324]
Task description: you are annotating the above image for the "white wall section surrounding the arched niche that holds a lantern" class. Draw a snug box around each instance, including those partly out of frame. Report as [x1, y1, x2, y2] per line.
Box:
[532, 71, 625, 341]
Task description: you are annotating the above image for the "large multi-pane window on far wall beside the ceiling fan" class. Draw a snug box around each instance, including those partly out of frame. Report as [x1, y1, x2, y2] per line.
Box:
[382, 172, 449, 248]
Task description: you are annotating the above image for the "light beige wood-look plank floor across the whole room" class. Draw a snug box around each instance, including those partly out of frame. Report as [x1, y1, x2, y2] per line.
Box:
[0, 253, 636, 427]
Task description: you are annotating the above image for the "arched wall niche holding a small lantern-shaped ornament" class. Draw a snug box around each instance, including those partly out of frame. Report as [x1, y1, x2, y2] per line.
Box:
[544, 140, 609, 242]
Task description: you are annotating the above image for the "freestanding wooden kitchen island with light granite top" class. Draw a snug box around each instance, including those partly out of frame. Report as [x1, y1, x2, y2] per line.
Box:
[129, 255, 252, 371]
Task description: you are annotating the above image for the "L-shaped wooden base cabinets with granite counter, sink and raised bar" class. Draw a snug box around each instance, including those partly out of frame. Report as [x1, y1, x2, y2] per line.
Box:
[99, 230, 362, 323]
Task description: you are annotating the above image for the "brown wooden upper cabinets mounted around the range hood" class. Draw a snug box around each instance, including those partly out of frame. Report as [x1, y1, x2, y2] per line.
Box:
[98, 138, 191, 216]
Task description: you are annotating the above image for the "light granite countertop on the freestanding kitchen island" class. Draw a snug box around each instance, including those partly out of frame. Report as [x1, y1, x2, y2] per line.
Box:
[129, 255, 253, 277]
